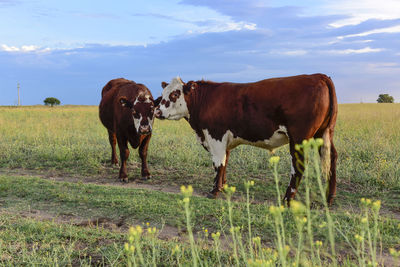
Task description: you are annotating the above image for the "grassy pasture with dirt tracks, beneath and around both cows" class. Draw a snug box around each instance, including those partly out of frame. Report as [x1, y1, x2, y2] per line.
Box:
[0, 104, 400, 266]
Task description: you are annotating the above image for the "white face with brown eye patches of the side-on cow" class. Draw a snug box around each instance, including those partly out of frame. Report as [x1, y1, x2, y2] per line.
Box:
[155, 77, 189, 120]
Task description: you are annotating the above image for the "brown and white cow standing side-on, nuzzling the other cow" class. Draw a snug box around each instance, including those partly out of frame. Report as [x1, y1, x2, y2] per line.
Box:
[156, 74, 337, 203]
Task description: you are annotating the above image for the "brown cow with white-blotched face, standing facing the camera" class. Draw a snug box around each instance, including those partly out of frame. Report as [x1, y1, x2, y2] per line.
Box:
[99, 78, 158, 182]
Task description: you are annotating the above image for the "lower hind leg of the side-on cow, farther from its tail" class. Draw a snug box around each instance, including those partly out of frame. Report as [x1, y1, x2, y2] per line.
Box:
[284, 141, 304, 205]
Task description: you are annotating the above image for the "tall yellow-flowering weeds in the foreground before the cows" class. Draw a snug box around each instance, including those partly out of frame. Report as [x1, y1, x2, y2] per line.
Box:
[120, 139, 400, 267]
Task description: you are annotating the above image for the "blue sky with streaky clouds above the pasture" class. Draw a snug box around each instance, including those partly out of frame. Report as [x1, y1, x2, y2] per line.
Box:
[0, 0, 400, 105]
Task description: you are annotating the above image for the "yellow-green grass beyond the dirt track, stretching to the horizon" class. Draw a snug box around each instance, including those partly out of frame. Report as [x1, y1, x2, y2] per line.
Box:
[0, 104, 400, 204]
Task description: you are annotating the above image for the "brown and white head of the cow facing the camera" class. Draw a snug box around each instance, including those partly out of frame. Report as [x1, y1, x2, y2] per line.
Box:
[119, 92, 159, 135]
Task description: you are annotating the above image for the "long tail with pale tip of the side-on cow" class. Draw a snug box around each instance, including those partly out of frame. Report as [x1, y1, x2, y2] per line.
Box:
[321, 75, 338, 182]
